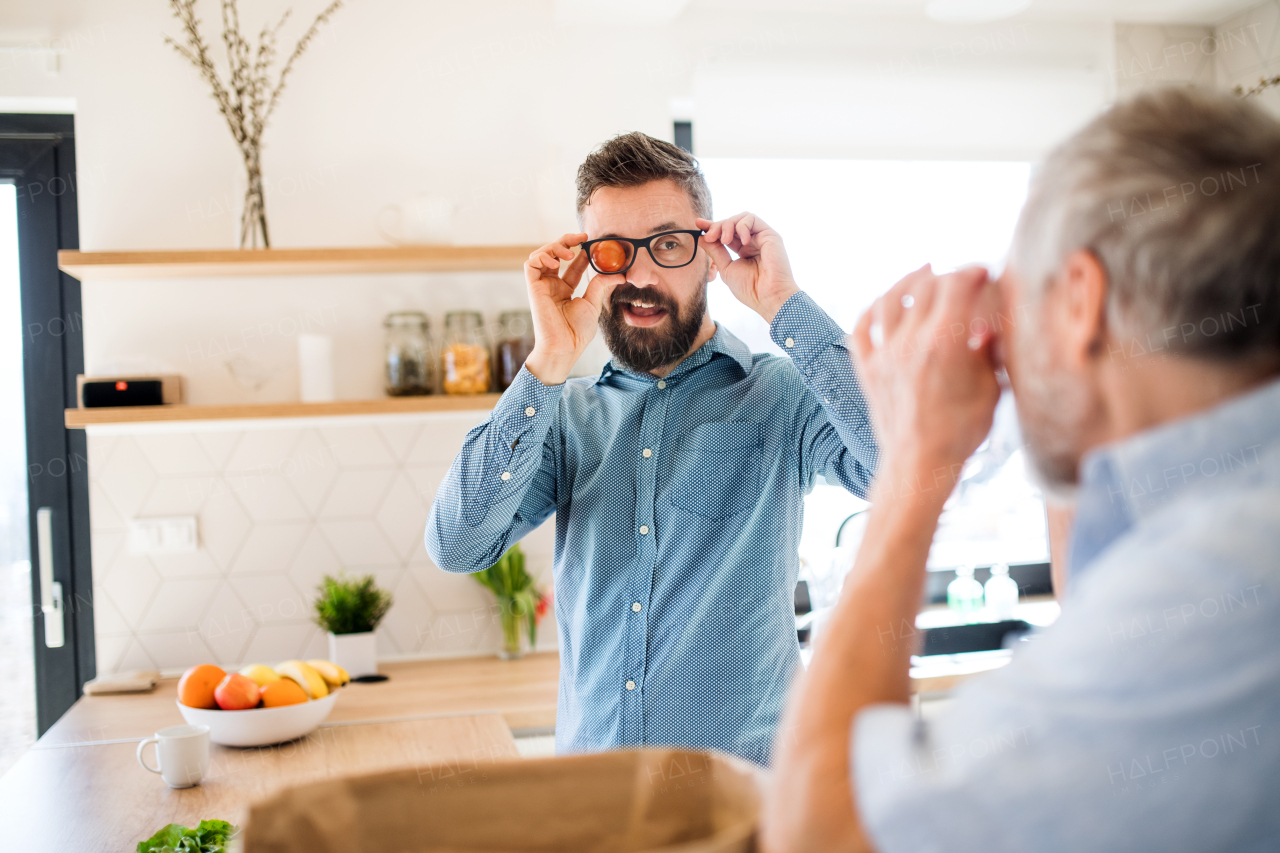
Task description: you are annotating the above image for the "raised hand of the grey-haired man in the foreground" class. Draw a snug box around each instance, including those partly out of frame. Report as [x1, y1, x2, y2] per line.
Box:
[850, 265, 1000, 498]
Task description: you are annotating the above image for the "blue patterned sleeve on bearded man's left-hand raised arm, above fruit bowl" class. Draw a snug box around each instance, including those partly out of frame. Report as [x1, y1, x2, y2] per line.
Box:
[426, 368, 564, 573]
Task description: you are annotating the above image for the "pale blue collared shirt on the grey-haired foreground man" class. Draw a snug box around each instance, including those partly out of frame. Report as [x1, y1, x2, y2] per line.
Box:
[854, 383, 1280, 853]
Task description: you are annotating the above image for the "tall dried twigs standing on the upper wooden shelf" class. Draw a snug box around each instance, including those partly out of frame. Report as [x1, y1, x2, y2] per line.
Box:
[165, 0, 342, 248]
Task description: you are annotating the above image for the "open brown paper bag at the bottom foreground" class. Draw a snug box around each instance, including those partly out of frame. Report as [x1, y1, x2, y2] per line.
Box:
[243, 748, 762, 853]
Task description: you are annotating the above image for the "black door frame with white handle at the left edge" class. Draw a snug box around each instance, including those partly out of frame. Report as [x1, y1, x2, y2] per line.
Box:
[0, 114, 97, 735]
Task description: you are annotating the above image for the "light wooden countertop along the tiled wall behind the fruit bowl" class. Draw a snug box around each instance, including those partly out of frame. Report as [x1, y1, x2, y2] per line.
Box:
[36, 652, 559, 748]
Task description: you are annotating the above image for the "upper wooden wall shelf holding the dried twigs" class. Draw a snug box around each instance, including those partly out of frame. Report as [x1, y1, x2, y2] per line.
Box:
[58, 246, 536, 282]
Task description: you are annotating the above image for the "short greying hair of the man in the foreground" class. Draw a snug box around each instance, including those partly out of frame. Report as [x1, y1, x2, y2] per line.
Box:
[1009, 88, 1280, 360]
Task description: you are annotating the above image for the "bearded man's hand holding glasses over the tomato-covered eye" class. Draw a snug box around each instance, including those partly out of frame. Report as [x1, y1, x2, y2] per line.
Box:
[525, 234, 618, 386]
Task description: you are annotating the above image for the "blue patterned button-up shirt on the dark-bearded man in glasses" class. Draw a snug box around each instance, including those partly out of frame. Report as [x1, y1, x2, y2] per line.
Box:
[426, 293, 877, 763]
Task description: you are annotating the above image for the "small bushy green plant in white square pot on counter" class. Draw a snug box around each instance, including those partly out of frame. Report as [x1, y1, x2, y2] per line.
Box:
[315, 575, 392, 679]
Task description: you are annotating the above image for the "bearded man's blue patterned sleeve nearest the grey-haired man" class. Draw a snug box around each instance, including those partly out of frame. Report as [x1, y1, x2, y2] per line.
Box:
[769, 292, 879, 498]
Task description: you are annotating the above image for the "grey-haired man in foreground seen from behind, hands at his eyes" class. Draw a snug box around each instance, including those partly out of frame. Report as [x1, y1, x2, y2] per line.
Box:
[762, 88, 1280, 853]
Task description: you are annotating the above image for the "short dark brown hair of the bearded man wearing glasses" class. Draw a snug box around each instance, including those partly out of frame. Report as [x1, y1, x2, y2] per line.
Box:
[577, 131, 712, 222]
